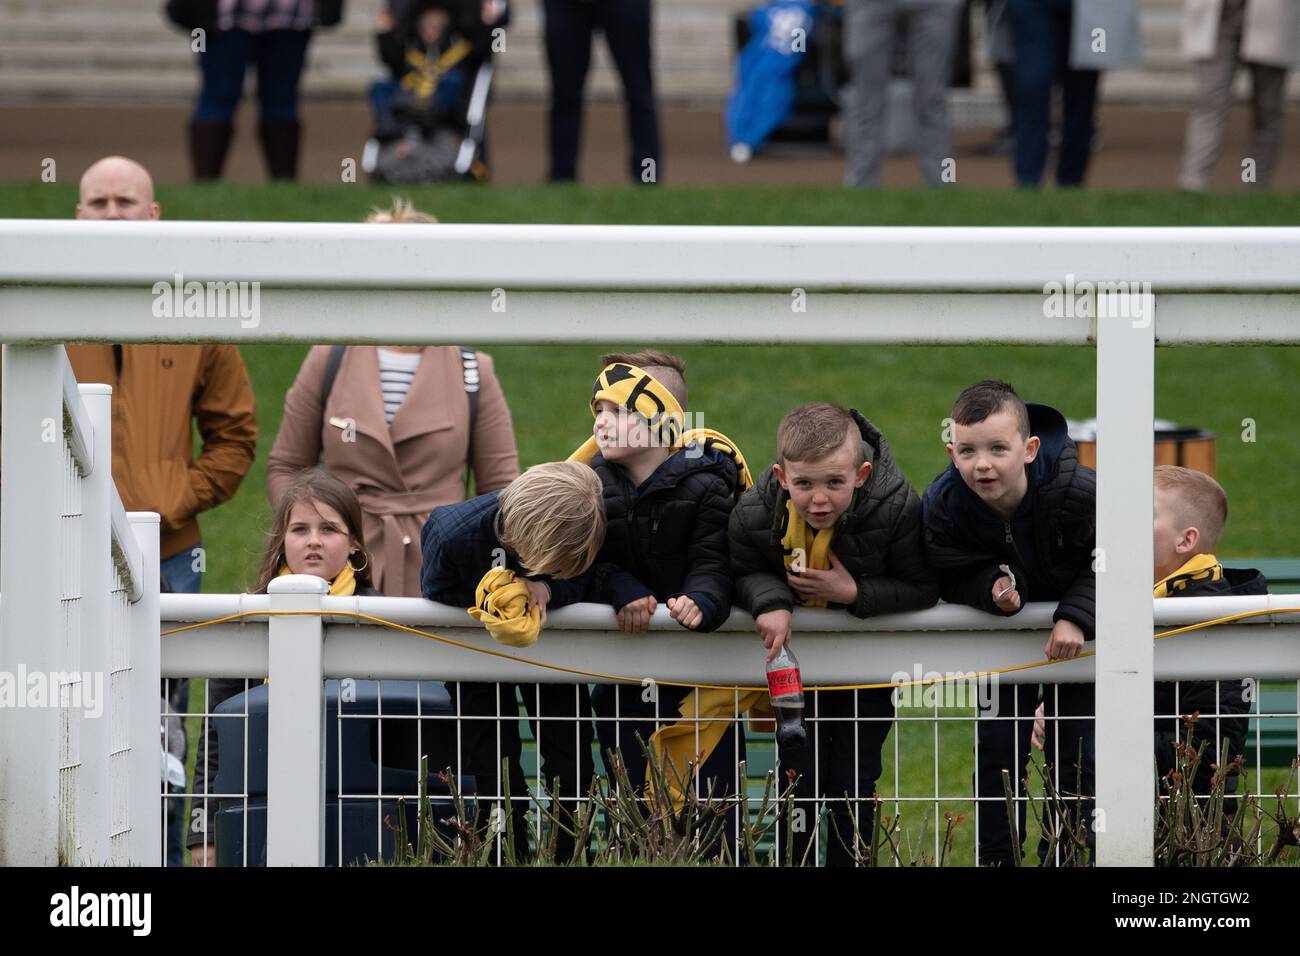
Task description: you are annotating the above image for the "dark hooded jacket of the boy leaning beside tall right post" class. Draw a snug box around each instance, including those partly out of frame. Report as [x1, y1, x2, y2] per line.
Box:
[924, 403, 1097, 640]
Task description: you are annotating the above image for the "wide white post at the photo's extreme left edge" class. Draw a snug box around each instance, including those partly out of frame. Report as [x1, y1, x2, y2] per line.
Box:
[0, 345, 68, 866]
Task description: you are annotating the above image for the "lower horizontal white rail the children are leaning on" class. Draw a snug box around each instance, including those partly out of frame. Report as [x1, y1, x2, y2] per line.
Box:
[161, 594, 1300, 684]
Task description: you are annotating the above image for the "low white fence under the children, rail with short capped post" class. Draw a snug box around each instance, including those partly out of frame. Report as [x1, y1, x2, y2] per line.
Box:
[161, 576, 1300, 865]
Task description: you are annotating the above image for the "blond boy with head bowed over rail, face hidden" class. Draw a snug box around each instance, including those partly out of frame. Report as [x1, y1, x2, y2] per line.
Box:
[420, 462, 606, 860]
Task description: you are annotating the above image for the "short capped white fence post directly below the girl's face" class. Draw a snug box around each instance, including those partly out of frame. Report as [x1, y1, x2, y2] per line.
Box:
[267, 575, 329, 866]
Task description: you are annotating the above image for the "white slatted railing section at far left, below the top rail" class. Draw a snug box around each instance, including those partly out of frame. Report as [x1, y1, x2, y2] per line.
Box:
[0, 346, 160, 865]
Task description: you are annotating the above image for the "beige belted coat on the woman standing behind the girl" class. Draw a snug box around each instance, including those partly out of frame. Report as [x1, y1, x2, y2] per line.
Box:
[267, 346, 519, 597]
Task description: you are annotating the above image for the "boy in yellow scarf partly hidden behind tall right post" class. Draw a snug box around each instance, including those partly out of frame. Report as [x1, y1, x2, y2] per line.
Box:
[1154, 464, 1269, 816]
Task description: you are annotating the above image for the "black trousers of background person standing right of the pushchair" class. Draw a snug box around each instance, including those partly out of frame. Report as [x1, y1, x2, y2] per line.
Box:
[543, 0, 663, 182]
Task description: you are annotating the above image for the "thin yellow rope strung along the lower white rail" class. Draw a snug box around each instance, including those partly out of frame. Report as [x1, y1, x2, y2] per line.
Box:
[159, 607, 1300, 692]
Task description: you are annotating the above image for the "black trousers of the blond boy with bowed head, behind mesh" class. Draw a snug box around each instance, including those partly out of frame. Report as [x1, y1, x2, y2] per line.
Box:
[447, 682, 593, 861]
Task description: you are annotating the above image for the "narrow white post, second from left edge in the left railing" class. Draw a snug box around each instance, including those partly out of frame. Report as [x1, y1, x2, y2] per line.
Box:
[77, 385, 116, 866]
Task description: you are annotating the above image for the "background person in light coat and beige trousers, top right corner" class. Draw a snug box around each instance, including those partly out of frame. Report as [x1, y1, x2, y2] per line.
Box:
[1178, 0, 1300, 190]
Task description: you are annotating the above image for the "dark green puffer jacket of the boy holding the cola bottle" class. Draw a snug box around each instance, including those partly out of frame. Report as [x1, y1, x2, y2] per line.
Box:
[728, 410, 939, 618]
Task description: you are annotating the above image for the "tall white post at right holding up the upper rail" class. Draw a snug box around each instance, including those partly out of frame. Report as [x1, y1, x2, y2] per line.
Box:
[1095, 308, 1156, 866]
